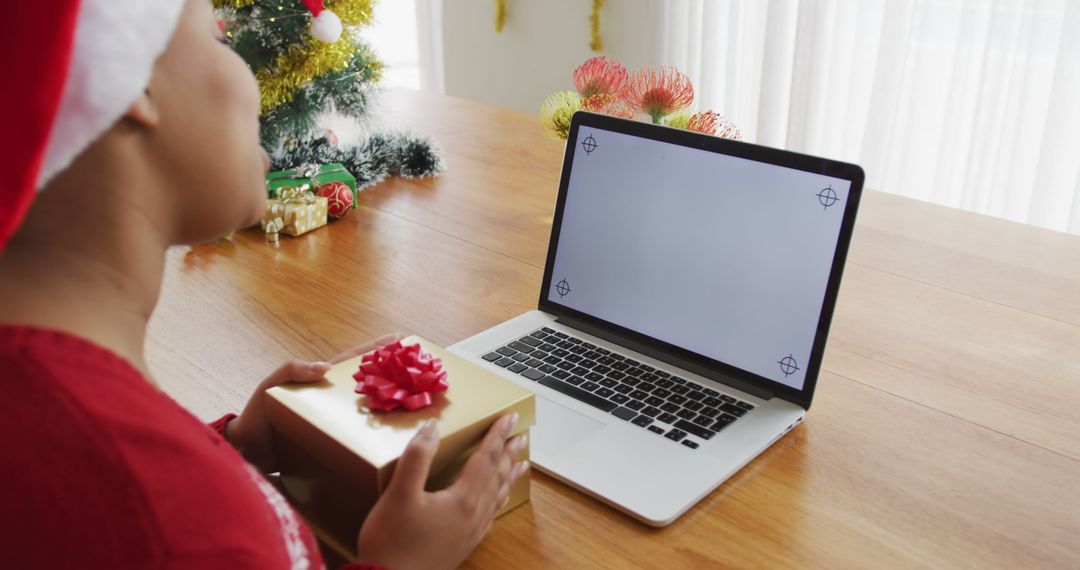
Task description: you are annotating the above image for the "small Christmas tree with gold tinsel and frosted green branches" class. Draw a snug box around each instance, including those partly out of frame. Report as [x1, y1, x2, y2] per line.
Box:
[214, 0, 442, 188]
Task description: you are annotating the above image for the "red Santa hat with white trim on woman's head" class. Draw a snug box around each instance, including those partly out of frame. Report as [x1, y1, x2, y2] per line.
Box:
[0, 0, 184, 250]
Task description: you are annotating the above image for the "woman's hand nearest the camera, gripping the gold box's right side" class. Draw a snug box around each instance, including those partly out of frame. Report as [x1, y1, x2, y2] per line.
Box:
[357, 415, 528, 570]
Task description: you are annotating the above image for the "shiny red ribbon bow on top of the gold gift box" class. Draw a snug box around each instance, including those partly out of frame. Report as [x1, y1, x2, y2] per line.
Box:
[352, 340, 450, 411]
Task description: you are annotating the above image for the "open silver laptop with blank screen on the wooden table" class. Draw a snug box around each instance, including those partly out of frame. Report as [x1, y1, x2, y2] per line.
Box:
[450, 112, 864, 527]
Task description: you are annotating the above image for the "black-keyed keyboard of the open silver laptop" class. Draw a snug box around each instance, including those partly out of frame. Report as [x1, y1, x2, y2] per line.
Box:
[484, 327, 754, 449]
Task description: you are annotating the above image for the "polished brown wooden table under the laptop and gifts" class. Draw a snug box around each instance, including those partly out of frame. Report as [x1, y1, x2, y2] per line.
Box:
[148, 91, 1080, 568]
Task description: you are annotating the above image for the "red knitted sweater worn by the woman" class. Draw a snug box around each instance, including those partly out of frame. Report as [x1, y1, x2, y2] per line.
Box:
[0, 325, 384, 570]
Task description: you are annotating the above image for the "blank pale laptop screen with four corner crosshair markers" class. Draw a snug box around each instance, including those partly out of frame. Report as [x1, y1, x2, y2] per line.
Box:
[541, 118, 853, 391]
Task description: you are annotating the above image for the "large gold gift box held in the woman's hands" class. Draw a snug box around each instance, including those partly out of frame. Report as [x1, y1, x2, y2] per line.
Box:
[267, 336, 536, 560]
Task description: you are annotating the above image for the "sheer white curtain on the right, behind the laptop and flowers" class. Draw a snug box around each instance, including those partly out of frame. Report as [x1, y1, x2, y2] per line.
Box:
[648, 0, 1080, 233]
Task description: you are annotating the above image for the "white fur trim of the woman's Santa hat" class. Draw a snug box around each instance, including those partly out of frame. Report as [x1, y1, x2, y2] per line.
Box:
[38, 0, 184, 190]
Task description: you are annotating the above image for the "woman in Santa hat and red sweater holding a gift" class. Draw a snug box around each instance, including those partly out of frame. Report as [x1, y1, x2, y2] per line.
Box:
[0, 0, 526, 569]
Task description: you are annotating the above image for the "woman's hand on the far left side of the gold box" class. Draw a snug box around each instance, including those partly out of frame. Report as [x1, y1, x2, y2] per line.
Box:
[225, 335, 401, 473]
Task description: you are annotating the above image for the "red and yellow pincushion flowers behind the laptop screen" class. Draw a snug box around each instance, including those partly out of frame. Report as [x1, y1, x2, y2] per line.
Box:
[540, 55, 742, 140]
